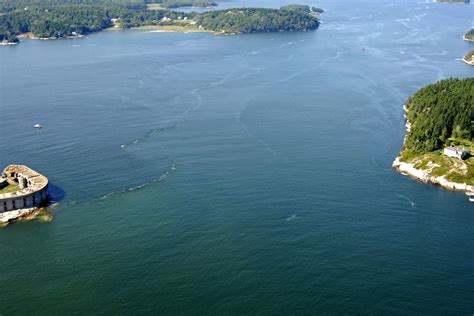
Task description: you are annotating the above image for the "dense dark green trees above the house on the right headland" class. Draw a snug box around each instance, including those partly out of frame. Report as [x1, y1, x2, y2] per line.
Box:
[404, 78, 474, 153]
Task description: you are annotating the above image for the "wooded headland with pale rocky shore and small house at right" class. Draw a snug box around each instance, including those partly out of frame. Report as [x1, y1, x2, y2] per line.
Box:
[393, 78, 474, 190]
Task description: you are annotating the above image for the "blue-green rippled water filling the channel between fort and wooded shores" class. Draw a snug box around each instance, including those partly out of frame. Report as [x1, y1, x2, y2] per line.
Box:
[0, 0, 474, 315]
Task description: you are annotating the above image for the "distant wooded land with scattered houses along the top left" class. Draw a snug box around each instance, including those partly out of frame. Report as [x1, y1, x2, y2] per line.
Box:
[0, 0, 322, 45]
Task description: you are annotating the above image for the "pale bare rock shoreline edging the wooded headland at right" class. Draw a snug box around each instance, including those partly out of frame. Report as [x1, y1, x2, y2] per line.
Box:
[392, 104, 474, 192]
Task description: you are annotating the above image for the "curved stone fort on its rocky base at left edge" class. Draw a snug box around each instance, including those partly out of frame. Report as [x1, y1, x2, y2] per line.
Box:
[0, 165, 48, 224]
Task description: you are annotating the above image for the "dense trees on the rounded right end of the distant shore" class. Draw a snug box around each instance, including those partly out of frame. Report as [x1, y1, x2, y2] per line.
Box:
[196, 8, 319, 33]
